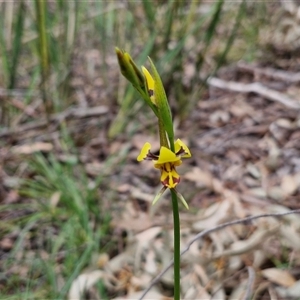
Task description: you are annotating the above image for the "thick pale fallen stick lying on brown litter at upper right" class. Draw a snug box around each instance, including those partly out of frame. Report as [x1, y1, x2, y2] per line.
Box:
[207, 77, 300, 109]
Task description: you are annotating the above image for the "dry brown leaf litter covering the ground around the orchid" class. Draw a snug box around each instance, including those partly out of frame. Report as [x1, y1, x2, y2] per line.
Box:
[0, 5, 300, 300]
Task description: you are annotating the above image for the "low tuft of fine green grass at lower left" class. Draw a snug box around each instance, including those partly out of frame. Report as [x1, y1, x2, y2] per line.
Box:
[2, 154, 110, 299]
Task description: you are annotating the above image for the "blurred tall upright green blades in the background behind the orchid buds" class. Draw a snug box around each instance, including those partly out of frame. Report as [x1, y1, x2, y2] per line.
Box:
[0, 0, 255, 129]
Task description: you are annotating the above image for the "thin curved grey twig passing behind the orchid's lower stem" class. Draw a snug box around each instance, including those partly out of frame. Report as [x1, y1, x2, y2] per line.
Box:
[139, 209, 300, 300]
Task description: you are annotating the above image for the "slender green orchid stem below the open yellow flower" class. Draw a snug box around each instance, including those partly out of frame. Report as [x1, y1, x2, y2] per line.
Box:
[170, 189, 180, 300]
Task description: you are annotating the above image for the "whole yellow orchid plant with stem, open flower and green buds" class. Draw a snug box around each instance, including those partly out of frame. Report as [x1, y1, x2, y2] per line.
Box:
[116, 48, 191, 300]
